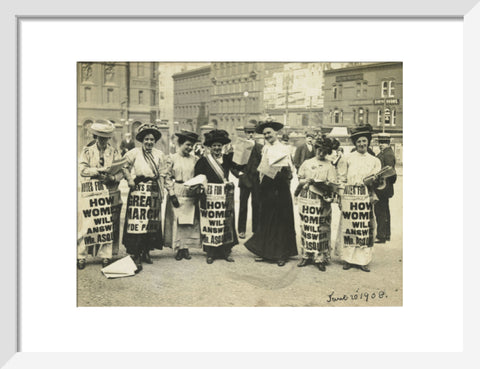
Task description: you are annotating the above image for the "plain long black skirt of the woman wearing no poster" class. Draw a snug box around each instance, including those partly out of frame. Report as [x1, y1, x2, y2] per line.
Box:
[245, 173, 298, 261]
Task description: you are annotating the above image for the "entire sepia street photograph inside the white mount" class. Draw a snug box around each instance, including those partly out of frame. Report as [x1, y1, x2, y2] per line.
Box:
[77, 61, 403, 307]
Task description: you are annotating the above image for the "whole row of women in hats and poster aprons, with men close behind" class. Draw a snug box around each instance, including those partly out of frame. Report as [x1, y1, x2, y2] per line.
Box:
[77, 120, 396, 272]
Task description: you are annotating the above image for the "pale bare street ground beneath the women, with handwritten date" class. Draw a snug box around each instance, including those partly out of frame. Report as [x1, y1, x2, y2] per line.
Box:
[77, 168, 403, 306]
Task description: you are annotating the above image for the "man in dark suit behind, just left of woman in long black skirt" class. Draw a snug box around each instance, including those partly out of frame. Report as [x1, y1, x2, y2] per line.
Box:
[238, 119, 263, 238]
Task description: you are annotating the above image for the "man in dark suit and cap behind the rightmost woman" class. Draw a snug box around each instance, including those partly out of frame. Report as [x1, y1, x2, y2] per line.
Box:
[375, 133, 397, 243]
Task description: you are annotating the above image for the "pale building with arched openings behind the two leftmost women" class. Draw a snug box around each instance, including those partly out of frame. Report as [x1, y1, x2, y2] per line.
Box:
[77, 62, 159, 150]
